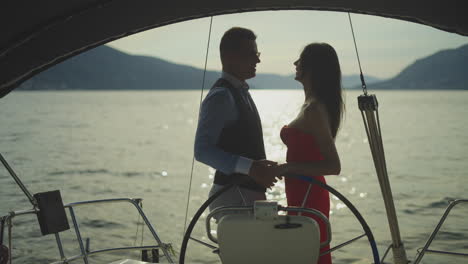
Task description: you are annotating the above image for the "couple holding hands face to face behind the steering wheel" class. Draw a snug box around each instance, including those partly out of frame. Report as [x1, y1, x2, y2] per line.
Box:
[195, 27, 344, 264]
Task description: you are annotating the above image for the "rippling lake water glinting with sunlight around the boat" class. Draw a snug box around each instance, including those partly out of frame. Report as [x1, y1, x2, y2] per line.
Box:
[0, 90, 468, 264]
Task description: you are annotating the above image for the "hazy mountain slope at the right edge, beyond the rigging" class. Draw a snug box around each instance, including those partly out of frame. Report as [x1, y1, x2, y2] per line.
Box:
[369, 44, 468, 90]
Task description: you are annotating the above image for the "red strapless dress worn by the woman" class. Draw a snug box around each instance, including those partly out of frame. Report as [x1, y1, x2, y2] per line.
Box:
[280, 126, 332, 264]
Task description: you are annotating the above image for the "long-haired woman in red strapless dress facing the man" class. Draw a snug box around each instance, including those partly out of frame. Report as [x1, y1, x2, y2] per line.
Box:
[280, 43, 344, 264]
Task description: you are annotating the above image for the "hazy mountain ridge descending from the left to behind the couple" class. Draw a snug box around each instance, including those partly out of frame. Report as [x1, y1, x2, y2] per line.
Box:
[19, 45, 379, 90]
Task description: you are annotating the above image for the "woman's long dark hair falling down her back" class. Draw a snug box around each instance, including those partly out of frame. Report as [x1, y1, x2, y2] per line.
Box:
[300, 43, 344, 138]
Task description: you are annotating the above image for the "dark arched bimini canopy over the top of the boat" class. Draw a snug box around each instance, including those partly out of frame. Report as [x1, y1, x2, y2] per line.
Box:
[0, 0, 468, 98]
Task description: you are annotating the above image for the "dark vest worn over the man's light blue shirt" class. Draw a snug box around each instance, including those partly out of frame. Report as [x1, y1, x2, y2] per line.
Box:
[212, 79, 266, 192]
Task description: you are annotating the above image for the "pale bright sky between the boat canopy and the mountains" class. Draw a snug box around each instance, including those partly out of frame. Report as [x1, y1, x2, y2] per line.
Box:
[107, 11, 468, 79]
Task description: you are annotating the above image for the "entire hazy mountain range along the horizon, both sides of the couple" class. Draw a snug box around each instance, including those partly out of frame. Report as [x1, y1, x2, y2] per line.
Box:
[20, 44, 468, 90]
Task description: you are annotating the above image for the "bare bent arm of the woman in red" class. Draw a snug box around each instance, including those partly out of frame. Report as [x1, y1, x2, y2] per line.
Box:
[280, 103, 341, 176]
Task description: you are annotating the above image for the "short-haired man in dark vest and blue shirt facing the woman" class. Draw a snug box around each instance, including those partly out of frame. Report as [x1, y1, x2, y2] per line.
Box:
[195, 27, 278, 210]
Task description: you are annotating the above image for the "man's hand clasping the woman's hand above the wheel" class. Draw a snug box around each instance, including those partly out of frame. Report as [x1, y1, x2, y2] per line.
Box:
[249, 160, 280, 188]
